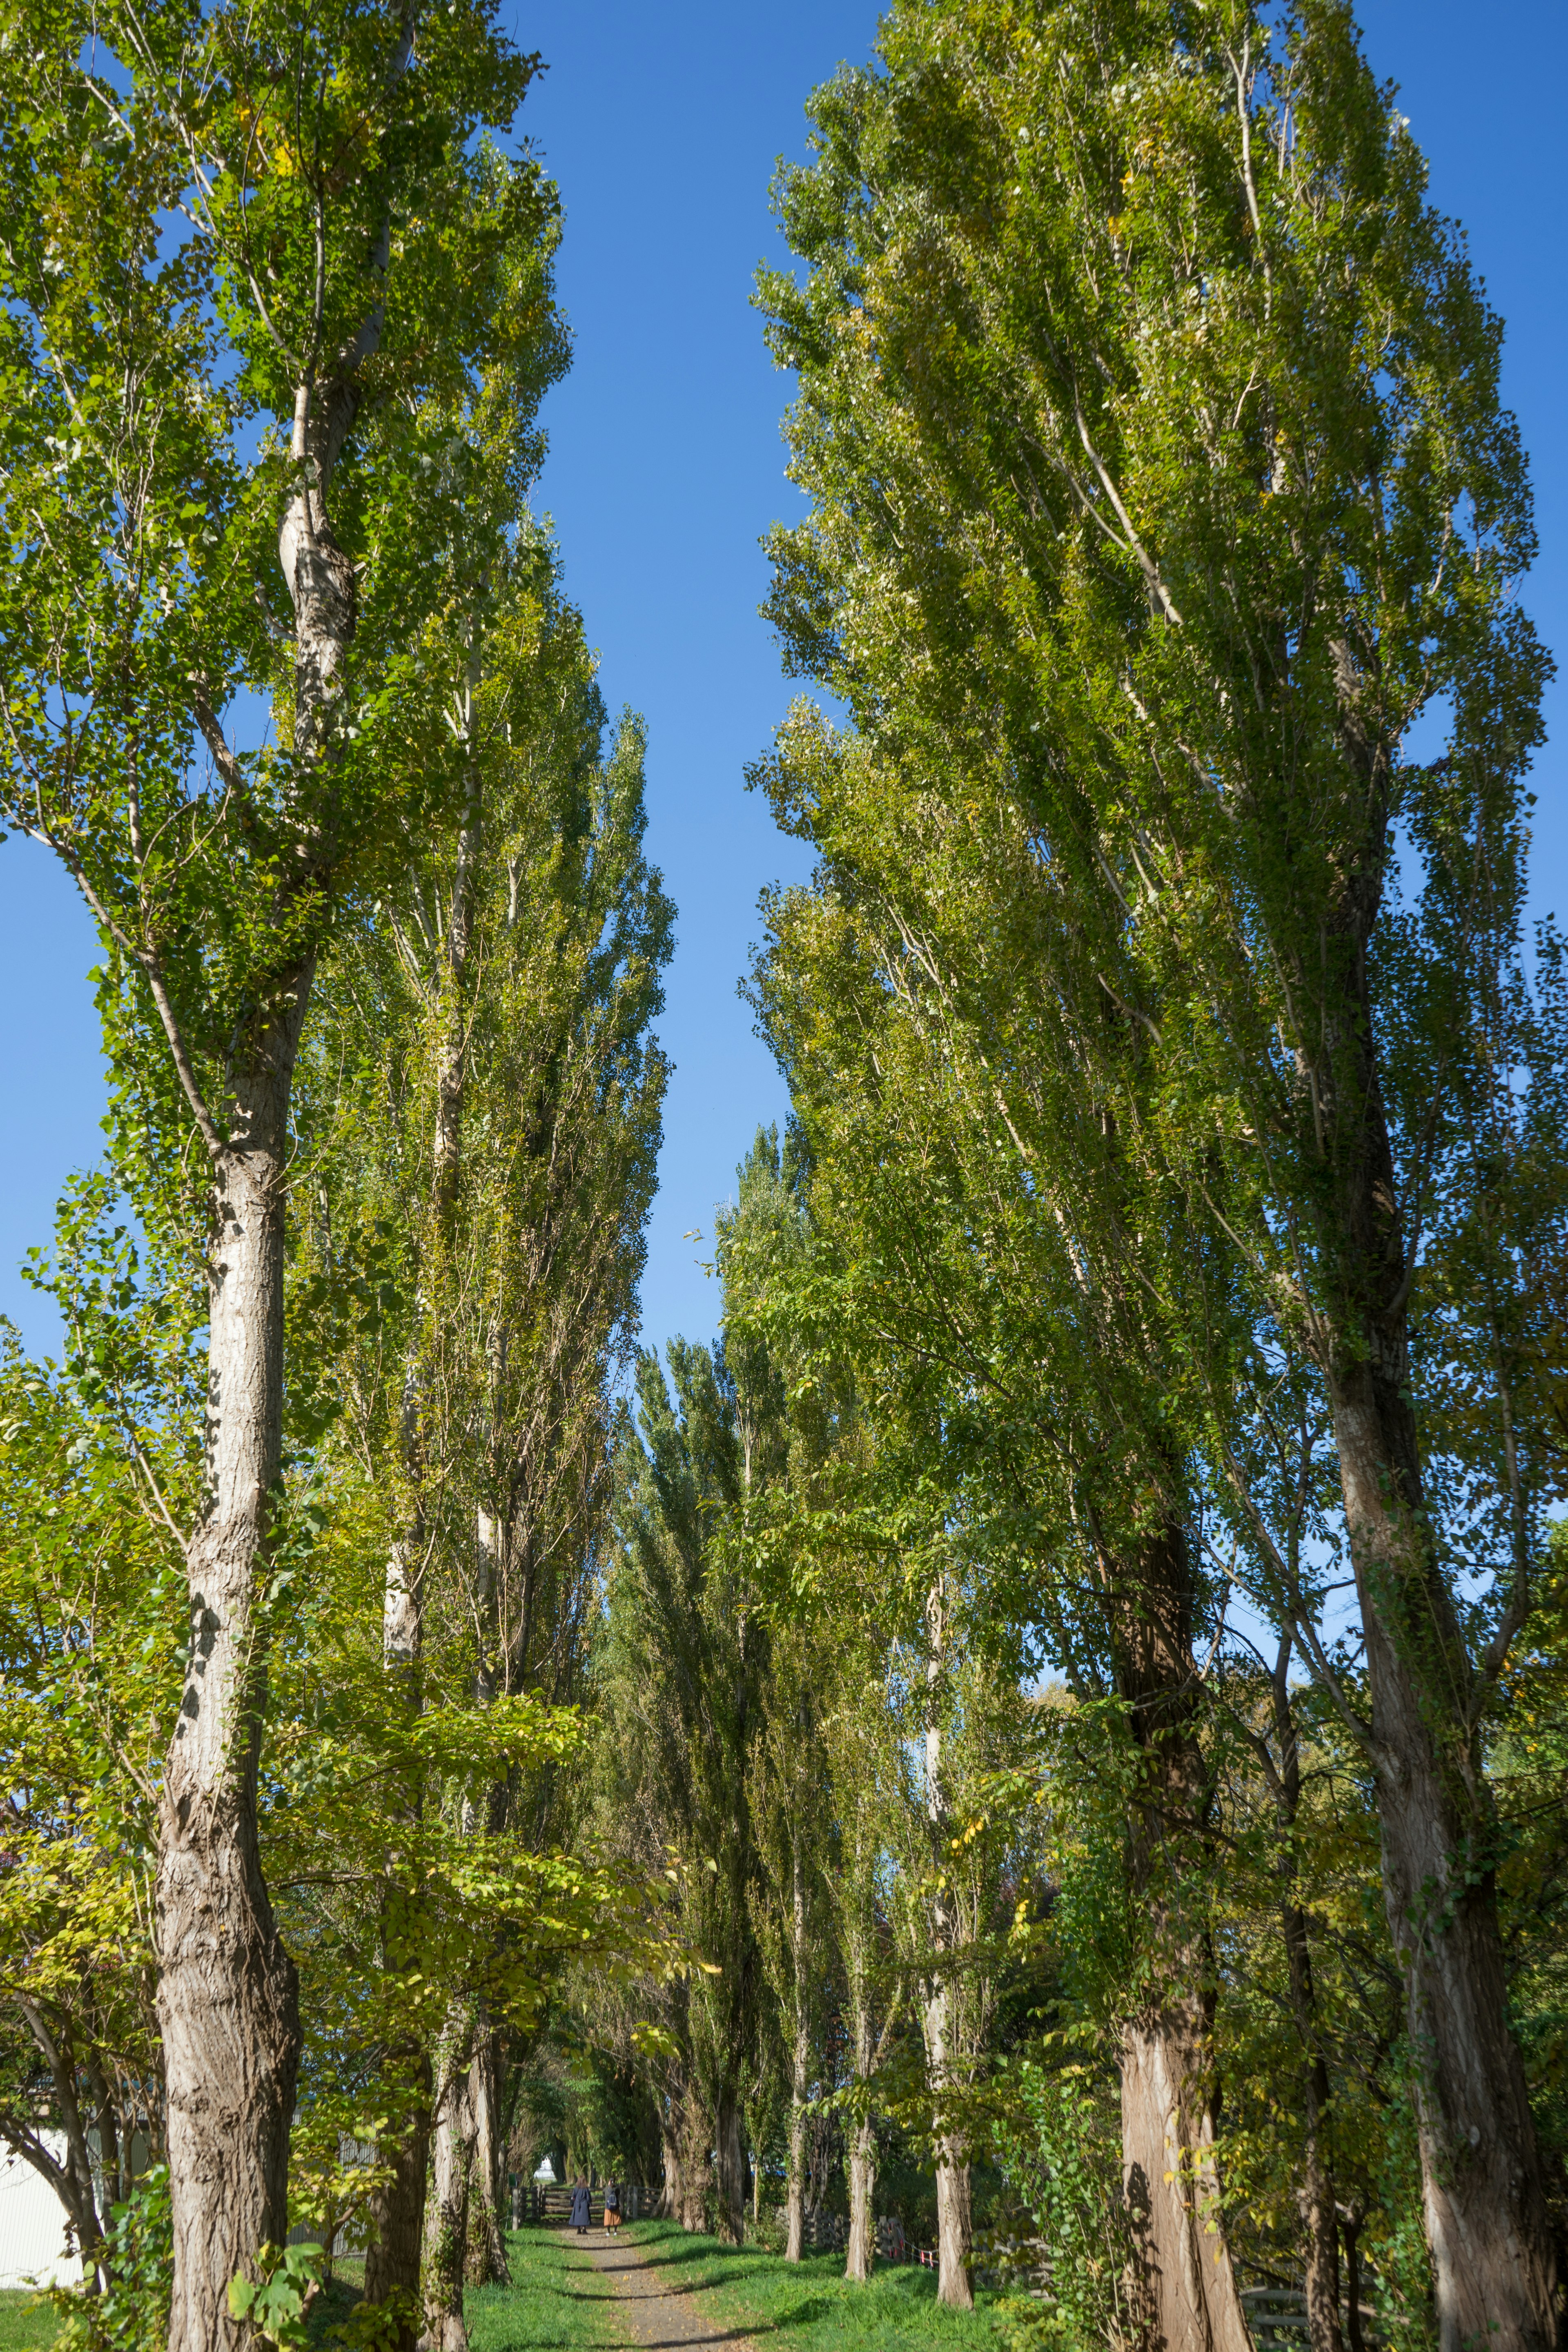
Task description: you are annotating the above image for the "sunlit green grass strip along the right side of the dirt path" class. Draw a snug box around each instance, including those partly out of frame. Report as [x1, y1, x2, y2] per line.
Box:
[621, 2220, 1002, 2352]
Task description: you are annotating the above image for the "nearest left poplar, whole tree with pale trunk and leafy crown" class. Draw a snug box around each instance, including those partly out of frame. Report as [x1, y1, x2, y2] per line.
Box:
[0, 0, 548, 2352]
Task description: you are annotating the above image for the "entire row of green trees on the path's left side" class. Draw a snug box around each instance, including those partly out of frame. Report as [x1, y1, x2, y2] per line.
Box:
[0, 13, 673, 2347]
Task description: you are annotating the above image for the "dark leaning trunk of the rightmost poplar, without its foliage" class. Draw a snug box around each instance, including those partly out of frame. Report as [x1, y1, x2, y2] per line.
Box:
[1316, 922, 1559, 2352]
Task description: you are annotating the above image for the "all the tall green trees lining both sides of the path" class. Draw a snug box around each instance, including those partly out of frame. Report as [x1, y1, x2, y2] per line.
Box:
[0, 0, 1568, 2352]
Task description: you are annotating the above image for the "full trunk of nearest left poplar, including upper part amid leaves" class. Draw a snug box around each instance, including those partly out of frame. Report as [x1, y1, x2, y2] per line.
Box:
[155, 193, 414, 2323]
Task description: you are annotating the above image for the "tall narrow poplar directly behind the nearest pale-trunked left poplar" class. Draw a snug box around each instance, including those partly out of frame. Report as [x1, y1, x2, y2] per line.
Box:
[292, 559, 673, 2343]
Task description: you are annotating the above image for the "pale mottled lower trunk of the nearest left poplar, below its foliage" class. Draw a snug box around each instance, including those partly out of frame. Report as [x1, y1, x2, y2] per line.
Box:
[155, 1100, 310, 2352]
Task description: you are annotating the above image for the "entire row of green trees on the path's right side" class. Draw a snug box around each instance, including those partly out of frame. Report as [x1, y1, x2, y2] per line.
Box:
[555, 0, 1568, 2352]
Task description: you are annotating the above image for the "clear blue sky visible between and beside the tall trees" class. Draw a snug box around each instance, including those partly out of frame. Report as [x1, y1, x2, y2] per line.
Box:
[0, 0, 1568, 1348]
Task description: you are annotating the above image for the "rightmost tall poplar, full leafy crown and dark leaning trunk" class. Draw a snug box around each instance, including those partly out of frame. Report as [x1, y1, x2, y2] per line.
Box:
[764, 0, 1556, 2352]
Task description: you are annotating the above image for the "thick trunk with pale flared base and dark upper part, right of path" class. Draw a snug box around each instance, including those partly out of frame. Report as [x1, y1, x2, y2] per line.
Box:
[1112, 1519, 1251, 2352]
